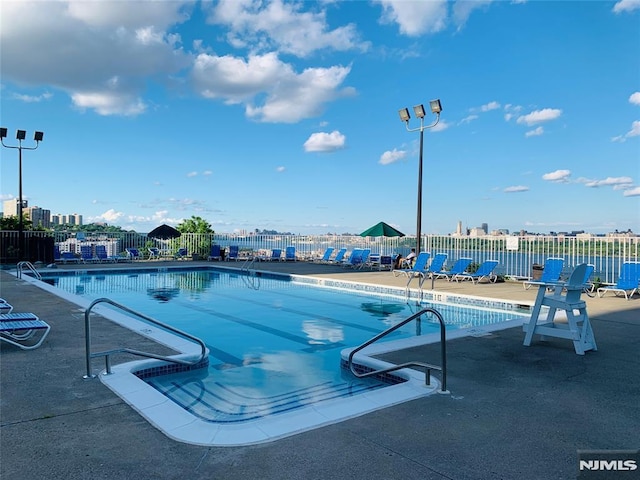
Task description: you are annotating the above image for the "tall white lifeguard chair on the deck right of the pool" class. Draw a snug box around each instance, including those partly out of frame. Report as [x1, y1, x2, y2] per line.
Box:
[522, 263, 598, 355]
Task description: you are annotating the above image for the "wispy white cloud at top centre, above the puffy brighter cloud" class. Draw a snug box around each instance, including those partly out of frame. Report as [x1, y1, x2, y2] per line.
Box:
[208, 0, 369, 57]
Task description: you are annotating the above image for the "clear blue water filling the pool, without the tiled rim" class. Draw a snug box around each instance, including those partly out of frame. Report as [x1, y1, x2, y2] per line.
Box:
[45, 269, 520, 423]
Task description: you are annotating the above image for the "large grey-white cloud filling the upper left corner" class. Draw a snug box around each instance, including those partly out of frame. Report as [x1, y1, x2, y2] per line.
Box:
[0, 1, 190, 115]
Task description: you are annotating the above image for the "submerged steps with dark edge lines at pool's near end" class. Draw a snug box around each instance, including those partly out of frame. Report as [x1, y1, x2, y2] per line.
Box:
[147, 375, 389, 423]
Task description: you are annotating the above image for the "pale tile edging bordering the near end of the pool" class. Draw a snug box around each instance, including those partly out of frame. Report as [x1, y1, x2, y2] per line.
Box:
[23, 275, 522, 446]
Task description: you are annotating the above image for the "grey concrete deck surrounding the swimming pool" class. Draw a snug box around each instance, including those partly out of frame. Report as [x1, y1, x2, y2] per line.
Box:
[0, 261, 640, 480]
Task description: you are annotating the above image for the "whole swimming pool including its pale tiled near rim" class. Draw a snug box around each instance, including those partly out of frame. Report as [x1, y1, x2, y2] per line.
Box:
[31, 268, 524, 445]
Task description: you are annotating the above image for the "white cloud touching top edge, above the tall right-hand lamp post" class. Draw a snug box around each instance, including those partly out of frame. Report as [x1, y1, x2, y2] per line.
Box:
[377, 0, 448, 37]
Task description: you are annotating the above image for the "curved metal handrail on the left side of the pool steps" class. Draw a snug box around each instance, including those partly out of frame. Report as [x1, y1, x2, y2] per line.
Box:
[84, 298, 207, 378]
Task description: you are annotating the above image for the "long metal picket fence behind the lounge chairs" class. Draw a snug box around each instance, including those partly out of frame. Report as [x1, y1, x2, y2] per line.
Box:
[0, 231, 640, 283]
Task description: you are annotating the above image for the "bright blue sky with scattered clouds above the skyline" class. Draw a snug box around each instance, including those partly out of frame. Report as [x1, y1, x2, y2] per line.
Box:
[0, 0, 640, 234]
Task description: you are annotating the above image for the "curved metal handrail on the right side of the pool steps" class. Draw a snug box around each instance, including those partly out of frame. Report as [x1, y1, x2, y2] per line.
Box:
[348, 308, 449, 393]
